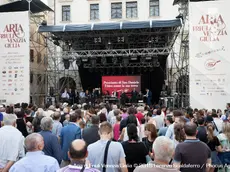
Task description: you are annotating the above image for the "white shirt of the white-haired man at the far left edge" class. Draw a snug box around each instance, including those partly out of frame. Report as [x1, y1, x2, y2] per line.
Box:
[0, 125, 25, 167]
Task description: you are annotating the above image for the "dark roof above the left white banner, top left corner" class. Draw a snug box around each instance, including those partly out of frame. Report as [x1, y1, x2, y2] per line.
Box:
[0, 0, 53, 13]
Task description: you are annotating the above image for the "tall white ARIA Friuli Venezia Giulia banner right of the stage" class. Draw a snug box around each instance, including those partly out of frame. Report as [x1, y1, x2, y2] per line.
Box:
[189, 1, 230, 110]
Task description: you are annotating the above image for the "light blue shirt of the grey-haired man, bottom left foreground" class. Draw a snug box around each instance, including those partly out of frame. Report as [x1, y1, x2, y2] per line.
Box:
[9, 151, 59, 172]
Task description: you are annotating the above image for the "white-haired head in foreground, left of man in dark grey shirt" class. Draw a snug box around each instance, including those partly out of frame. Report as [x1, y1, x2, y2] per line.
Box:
[153, 136, 175, 162]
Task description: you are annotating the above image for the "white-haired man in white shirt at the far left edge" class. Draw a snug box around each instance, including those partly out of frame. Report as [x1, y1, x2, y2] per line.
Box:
[0, 114, 25, 172]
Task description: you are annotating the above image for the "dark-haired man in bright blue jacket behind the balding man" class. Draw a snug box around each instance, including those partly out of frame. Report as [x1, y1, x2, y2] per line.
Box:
[60, 113, 82, 167]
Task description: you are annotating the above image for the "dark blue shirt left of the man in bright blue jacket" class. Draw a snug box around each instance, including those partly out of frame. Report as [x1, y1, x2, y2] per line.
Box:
[39, 131, 62, 164]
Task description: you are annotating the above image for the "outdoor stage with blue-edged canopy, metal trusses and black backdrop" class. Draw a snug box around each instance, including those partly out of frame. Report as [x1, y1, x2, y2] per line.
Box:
[38, 19, 181, 102]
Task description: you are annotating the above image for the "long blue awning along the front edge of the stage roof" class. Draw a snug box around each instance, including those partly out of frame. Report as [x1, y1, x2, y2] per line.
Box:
[38, 19, 182, 32]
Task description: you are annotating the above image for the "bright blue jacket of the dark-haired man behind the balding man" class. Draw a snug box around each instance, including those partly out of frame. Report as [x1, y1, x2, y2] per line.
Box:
[60, 122, 81, 161]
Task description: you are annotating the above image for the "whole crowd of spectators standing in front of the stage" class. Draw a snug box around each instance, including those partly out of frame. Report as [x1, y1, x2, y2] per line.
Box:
[0, 103, 230, 172]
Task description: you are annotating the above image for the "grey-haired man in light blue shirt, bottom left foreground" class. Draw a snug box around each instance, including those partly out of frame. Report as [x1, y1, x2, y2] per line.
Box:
[9, 133, 59, 172]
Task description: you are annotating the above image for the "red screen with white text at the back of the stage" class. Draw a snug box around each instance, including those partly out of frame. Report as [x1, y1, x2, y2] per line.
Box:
[102, 76, 141, 95]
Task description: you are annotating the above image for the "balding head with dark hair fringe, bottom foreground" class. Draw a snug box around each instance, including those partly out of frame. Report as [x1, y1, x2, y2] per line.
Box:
[68, 139, 88, 161]
